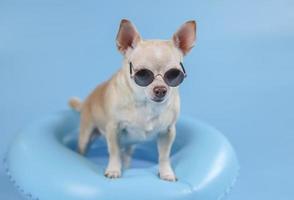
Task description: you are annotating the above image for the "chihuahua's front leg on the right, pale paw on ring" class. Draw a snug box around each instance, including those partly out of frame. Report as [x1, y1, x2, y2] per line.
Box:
[157, 125, 177, 181]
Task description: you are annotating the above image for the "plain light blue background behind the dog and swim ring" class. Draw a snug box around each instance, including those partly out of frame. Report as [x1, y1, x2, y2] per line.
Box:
[0, 0, 294, 200]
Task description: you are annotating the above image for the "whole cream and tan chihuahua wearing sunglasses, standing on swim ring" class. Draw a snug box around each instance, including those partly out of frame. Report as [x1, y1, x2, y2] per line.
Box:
[69, 19, 196, 181]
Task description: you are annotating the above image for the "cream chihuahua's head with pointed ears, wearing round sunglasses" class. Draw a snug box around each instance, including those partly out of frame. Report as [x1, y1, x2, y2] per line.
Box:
[116, 19, 196, 103]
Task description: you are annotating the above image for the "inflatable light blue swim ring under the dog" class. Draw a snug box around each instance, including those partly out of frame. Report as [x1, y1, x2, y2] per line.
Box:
[4, 111, 239, 200]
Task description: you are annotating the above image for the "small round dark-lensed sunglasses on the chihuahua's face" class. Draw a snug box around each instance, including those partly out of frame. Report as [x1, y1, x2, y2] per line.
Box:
[130, 62, 187, 87]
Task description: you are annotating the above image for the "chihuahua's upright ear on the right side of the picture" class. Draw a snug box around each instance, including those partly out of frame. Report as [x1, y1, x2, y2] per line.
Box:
[173, 20, 196, 55]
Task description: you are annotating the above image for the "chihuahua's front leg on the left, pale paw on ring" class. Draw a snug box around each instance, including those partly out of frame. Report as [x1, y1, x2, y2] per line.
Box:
[104, 124, 121, 178]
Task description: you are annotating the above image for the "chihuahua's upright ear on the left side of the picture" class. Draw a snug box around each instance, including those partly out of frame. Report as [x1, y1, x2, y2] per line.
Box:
[116, 19, 141, 54]
